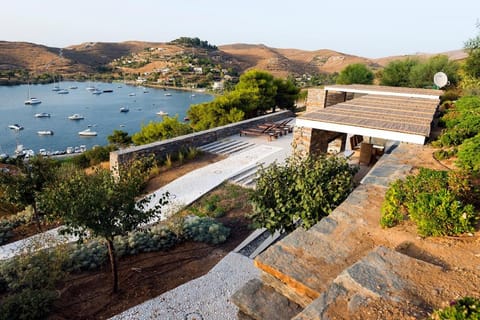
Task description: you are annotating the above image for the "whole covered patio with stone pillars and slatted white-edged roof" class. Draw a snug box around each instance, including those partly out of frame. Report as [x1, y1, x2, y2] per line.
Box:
[294, 85, 443, 164]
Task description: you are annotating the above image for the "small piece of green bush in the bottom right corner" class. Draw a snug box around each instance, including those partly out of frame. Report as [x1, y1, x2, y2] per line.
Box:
[432, 297, 480, 320]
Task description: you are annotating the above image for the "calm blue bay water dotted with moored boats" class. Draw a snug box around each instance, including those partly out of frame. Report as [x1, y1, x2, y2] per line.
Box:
[0, 81, 213, 155]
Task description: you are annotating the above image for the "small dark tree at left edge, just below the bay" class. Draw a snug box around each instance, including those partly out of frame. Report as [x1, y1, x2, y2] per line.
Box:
[0, 155, 58, 231]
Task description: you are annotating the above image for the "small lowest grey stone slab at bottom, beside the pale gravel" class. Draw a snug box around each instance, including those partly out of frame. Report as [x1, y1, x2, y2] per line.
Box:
[230, 279, 302, 320]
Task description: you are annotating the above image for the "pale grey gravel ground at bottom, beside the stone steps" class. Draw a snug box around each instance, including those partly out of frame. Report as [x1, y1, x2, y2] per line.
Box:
[111, 253, 260, 320]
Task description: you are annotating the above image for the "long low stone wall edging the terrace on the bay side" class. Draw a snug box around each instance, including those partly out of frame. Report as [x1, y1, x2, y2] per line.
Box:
[110, 110, 294, 169]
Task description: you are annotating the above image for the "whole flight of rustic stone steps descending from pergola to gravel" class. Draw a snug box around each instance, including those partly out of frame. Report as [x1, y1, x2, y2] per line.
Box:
[231, 145, 475, 320]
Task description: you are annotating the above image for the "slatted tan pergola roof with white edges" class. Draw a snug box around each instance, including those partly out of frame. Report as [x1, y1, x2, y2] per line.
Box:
[296, 85, 442, 144]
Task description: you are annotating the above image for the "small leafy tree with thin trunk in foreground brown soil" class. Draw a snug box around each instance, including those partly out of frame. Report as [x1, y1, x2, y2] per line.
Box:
[41, 161, 168, 292]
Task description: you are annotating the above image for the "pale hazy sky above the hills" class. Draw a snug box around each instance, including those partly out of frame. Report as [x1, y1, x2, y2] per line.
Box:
[0, 0, 480, 58]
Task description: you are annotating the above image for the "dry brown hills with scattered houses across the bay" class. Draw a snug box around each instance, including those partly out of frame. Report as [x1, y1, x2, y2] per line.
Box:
[0, 41, 466, 80]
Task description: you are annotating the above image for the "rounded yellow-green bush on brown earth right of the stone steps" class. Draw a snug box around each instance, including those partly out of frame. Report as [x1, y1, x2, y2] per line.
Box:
[380, 168, 478, 236]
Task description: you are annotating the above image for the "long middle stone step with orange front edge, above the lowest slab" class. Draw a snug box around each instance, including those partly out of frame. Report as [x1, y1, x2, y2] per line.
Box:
[254, 186, 380, 307]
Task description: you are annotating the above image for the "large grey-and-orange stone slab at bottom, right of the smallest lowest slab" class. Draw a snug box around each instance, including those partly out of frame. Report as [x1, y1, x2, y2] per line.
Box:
[294, 246, 448, 320]
